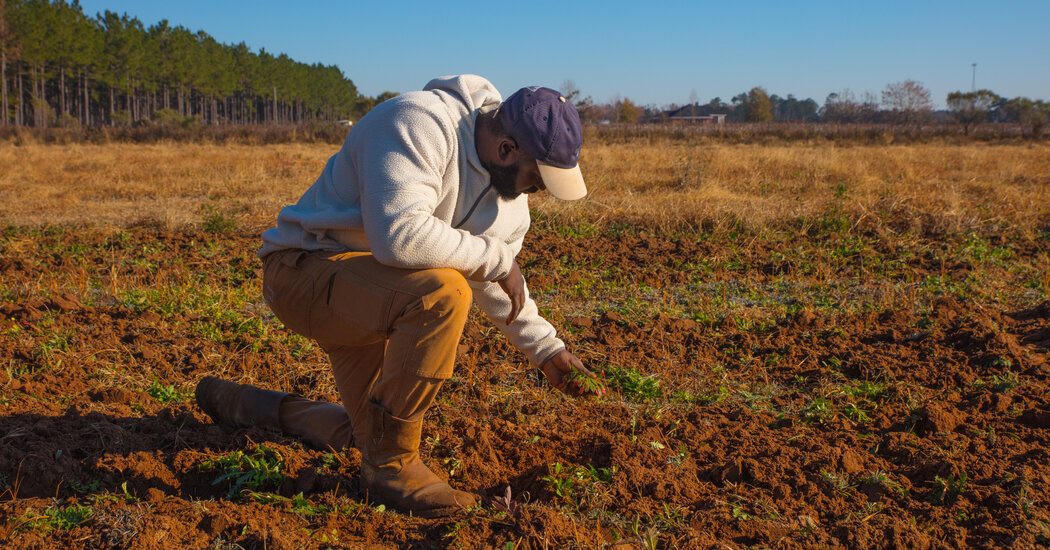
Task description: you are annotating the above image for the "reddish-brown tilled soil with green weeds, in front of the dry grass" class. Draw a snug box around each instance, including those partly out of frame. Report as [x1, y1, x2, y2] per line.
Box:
[0, 228, 1050, 549]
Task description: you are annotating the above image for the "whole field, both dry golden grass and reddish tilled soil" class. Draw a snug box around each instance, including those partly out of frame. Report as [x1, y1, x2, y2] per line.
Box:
[0, 136, 1050, 550]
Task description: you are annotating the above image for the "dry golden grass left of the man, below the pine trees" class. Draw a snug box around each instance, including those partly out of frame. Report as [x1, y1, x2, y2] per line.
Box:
[0, 144, 327, 228]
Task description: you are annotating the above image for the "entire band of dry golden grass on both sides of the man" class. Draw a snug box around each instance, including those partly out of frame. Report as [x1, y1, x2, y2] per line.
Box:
[0, 139, 1050, 233]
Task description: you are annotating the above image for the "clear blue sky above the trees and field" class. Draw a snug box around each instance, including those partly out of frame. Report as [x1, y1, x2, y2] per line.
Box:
[81, 0, 1050, 106]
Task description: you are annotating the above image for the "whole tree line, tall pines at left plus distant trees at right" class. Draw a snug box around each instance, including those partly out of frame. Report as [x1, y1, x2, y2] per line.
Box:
[0, 0, 1050, 134]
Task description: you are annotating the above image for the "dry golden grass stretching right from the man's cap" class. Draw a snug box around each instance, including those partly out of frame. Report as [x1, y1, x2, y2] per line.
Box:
[536, 142, 1050, 232]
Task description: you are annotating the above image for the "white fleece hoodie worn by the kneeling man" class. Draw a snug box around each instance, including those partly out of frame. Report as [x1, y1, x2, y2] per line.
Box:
[258, 75, 565, 365]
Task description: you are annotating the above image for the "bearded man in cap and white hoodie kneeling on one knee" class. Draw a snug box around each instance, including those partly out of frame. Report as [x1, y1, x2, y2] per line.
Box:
[196, 75, 594, 516]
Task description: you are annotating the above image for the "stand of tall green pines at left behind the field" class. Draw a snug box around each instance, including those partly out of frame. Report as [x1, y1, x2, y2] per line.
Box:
[0, 0, 393, 127]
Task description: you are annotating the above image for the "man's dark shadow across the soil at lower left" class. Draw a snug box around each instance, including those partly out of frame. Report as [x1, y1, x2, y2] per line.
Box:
[0, 403, 360, 500]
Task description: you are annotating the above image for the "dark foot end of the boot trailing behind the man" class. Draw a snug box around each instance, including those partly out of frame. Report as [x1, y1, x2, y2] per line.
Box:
[193, 376, 292, 431]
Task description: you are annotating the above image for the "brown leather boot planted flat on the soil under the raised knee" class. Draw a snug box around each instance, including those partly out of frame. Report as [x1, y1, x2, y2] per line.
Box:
[360, 403, 478, 517]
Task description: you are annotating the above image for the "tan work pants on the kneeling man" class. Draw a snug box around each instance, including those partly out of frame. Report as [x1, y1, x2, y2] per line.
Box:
[263, 250, 471, 449]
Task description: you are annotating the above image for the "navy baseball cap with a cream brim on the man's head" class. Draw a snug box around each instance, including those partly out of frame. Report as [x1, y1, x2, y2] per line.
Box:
[498, 86, 587, 200]
